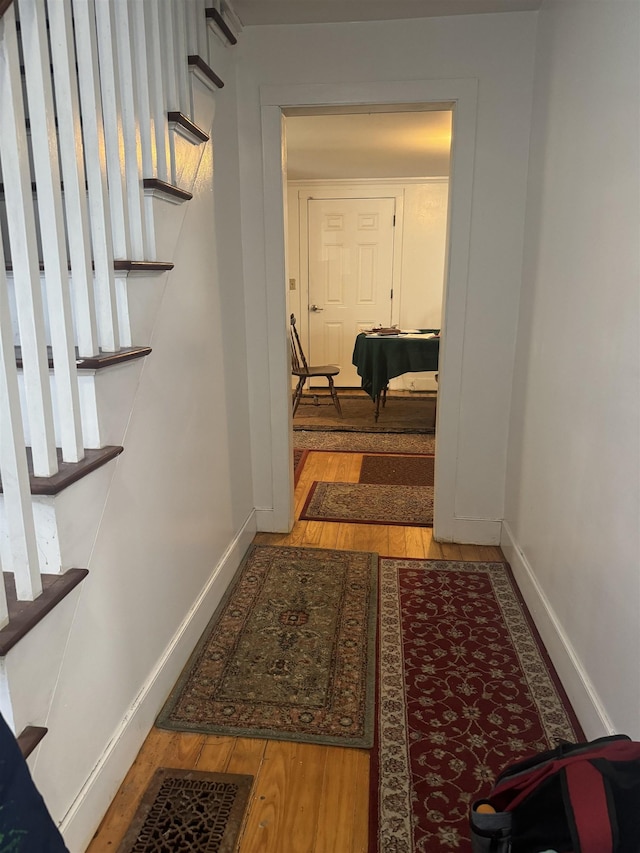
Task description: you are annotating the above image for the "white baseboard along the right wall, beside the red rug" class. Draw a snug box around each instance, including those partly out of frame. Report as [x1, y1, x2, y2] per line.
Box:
[500, 522, 615, 740]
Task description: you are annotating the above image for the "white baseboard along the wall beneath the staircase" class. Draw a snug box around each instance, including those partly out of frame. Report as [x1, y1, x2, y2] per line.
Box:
[60, 512, 256, 853]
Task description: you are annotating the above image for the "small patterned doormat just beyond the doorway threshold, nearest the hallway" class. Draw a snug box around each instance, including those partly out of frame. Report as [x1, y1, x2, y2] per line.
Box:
[300, 480, 433, 527]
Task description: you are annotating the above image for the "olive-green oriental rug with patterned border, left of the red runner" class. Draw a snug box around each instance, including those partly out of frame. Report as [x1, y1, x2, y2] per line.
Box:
[157, 545, 377, 748]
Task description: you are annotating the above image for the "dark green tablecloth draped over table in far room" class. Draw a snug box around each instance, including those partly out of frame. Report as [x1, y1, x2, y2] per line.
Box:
[352, 333, 440, 401]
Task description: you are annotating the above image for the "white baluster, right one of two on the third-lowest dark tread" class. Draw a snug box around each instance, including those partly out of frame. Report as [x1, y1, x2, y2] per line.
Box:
[20, 0, 84, 462]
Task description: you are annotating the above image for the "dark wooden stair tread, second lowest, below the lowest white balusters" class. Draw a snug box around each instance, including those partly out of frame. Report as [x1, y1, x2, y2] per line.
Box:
[0, 569, 89, 656]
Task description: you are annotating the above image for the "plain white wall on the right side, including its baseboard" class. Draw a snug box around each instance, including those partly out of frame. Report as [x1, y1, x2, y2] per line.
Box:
[504, 0, 640, 739]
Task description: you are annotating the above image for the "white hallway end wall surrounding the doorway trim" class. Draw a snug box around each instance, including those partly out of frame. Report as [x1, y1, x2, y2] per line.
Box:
[239, 13, 536, 542]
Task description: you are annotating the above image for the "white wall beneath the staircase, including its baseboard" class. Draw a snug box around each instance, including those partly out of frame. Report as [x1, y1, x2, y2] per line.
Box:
[25, 41, 255, 853]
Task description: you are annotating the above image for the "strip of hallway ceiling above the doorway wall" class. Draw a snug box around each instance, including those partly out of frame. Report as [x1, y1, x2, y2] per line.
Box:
[229, 0, 542, 27]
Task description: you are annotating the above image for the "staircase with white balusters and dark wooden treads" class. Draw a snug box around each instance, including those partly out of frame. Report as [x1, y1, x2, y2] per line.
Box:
[0, 0, 238, 849]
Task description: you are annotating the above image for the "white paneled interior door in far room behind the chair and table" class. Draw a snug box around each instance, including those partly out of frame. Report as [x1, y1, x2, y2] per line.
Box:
[308, 198, 395, 388]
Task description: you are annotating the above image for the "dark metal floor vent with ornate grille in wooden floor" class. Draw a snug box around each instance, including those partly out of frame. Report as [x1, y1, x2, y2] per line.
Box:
[118, 767, 253, 853]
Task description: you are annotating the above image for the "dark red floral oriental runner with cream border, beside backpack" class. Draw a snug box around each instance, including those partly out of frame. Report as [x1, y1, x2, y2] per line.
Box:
[369, 559, 584, 853]
